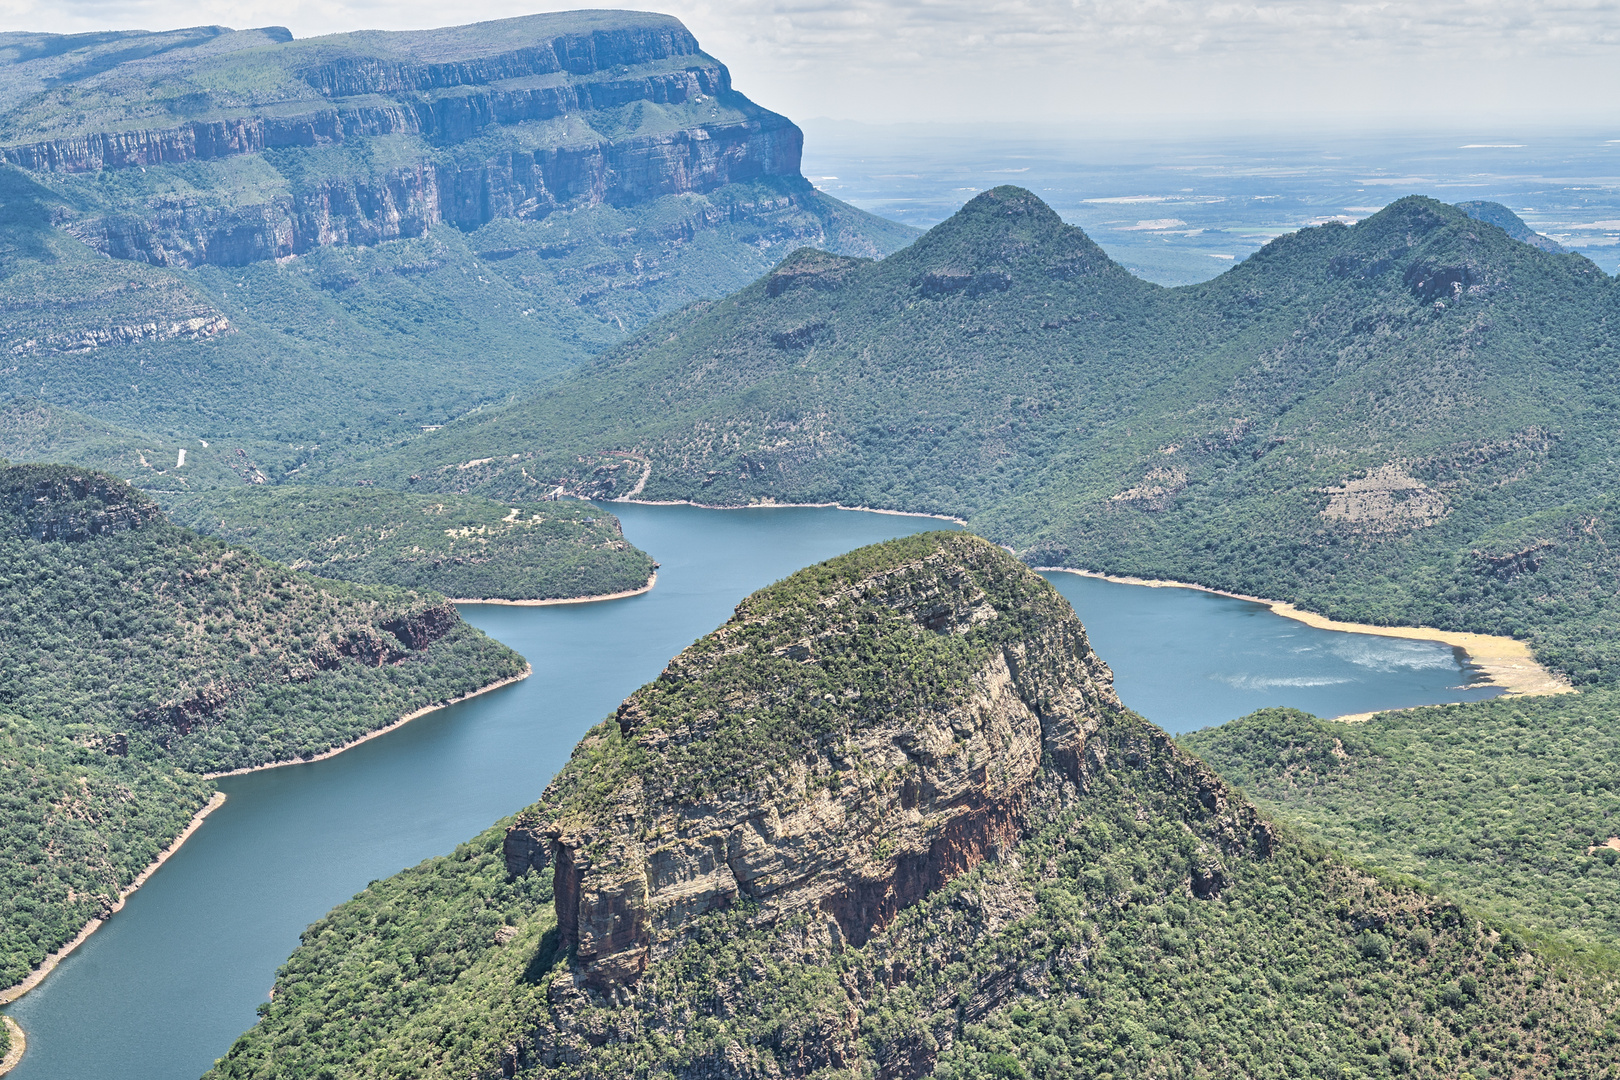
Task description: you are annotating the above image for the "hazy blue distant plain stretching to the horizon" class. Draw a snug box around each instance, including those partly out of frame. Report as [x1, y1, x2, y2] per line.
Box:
[800, 120, 1620, 285]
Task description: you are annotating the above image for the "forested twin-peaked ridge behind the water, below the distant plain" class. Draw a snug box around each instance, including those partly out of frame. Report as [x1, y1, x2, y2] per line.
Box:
[351, 188, 1620, 683]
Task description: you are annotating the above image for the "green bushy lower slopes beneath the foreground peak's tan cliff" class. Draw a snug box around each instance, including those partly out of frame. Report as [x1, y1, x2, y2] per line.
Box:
[207, 777, 1620, 1080]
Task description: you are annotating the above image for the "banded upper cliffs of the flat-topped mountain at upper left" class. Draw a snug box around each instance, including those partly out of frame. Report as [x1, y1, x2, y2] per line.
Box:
[0, 13, 808, 267]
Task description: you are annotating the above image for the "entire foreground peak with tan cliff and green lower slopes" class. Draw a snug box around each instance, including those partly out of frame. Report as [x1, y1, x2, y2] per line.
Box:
[209, 533, 1609, 1080]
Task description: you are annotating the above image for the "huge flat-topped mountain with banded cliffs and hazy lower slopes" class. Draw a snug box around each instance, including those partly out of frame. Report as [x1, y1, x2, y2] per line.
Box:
[0, 11, 915, 445]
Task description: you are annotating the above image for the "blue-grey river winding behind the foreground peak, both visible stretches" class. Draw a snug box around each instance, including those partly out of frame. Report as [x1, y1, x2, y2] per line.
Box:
[8, 505, 1494, 1080]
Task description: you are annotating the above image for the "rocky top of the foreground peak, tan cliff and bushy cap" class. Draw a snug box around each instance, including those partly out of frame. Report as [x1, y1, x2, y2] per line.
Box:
[505, 534, 1264, 1016]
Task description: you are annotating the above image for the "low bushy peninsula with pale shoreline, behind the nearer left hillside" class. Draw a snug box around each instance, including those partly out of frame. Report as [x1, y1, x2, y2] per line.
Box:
[161, 486, 653, 601]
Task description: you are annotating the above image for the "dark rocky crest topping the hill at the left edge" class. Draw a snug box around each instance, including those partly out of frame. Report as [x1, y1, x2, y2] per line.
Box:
[0, 465, 164, 542]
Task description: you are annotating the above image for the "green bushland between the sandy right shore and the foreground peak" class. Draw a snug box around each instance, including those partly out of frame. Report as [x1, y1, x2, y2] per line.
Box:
[1181, 702, 1620, 962]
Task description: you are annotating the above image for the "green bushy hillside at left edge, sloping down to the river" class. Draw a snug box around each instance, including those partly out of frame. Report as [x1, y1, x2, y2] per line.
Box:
[0, 466, 523, 986]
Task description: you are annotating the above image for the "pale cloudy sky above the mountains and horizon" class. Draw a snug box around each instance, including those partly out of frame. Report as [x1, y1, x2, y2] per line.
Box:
[0, 0, 1620, 131]
